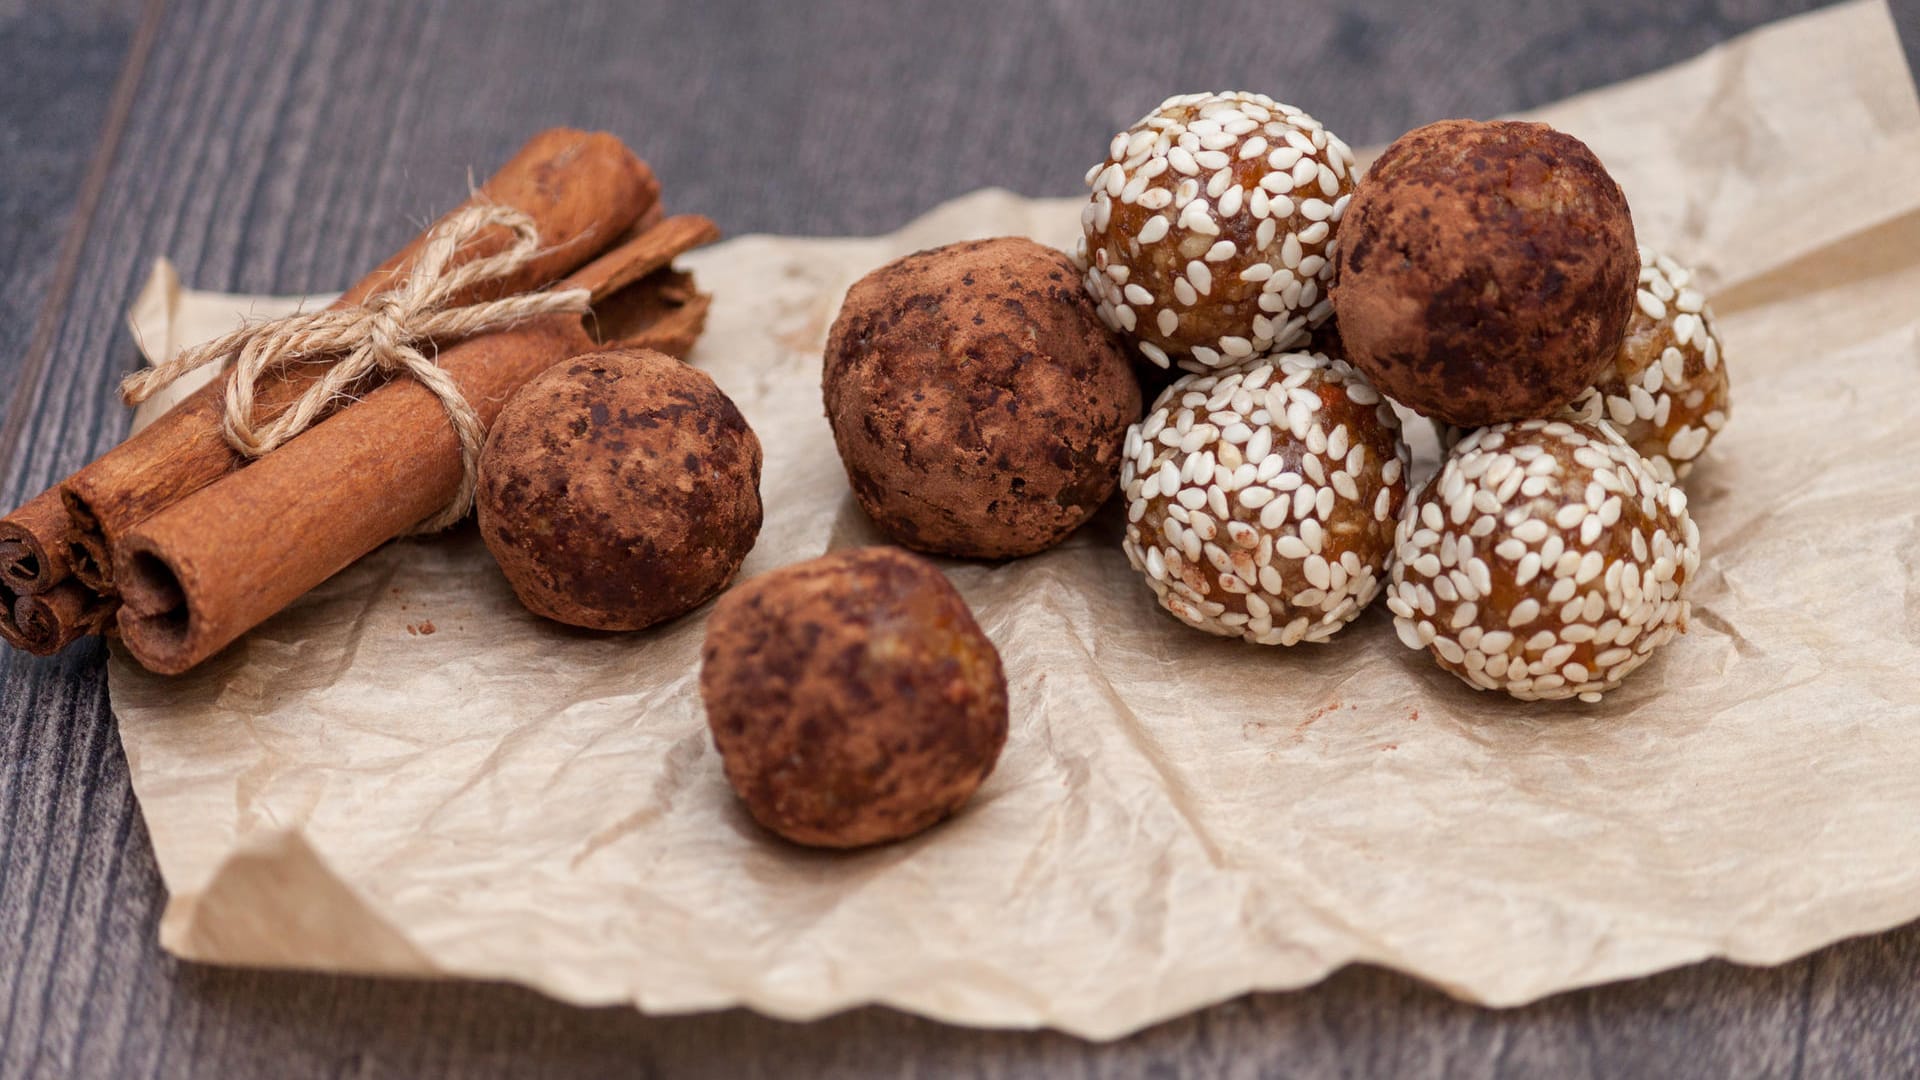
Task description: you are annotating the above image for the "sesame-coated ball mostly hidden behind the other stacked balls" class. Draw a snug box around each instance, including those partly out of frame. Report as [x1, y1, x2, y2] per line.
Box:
[1569, 248, 1728, 480]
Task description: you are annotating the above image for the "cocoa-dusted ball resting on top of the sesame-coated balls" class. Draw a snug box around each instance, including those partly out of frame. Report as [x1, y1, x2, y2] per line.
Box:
[1332, 119, 1640, 427]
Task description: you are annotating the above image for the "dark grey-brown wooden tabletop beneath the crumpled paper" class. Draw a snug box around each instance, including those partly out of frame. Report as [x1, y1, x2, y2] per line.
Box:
[0, 0, 1920, 1076]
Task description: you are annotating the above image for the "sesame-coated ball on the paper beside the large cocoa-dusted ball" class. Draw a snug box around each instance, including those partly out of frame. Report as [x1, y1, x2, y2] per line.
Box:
[1119, 354, 1407, 646]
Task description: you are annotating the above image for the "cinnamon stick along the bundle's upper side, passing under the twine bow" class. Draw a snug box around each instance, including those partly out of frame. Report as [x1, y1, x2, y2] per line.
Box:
[61, 129, 659, 590]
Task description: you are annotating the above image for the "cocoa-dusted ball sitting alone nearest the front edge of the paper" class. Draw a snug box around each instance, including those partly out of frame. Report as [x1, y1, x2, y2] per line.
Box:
[701, 548, 1006, 847]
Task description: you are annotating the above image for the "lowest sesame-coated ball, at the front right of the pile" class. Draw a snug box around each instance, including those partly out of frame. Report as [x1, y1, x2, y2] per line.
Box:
[1386, 421, 1699, 701]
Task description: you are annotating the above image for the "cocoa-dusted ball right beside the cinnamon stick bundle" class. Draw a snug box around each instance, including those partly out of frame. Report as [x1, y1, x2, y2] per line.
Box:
[474, 350, 760, 630]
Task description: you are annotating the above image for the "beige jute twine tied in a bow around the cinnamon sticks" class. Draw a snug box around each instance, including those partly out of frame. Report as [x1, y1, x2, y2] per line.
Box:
[121, 204, 589, 532]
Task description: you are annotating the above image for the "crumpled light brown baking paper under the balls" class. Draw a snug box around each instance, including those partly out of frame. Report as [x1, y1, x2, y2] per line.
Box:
[111, 4, 1920, 1038]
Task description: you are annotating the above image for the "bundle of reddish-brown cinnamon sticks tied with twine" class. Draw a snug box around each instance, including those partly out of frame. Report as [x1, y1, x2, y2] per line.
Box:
[0, 129, 718, 675]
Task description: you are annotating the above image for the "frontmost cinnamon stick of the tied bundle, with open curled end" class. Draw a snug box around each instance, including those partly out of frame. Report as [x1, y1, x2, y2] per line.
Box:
[115, 219, 718, 675]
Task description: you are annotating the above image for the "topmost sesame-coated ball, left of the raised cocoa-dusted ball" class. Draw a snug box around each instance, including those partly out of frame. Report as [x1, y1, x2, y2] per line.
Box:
[1079, 92, 1354, 371]
